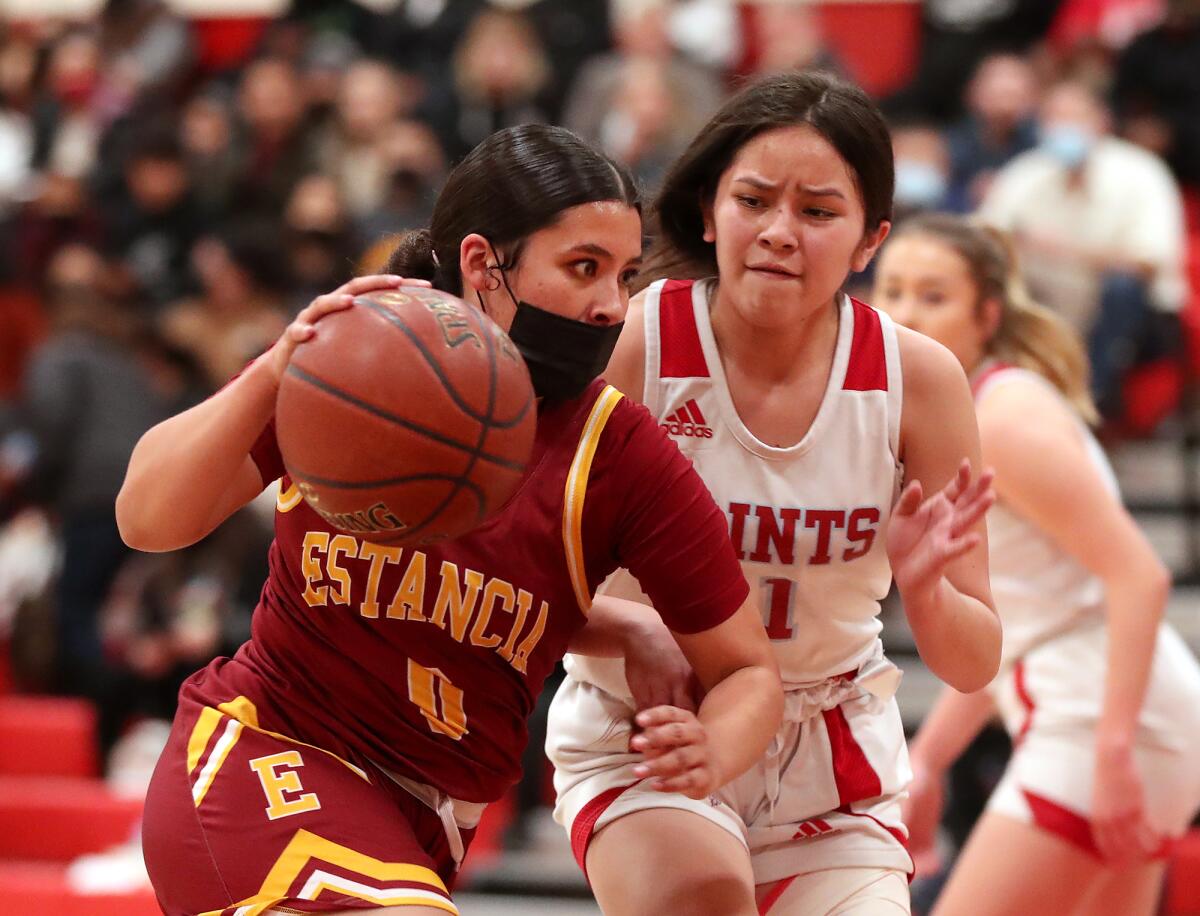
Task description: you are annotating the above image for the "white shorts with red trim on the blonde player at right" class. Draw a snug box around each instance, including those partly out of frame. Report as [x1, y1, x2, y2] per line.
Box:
[988, 623, 1200, 855]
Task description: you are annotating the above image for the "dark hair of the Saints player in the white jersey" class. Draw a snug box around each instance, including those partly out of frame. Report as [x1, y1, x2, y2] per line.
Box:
[638, 71, 895, 285]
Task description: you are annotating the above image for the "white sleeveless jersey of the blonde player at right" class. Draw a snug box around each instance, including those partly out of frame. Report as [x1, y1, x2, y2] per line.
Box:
[973, 364, 1121, 665]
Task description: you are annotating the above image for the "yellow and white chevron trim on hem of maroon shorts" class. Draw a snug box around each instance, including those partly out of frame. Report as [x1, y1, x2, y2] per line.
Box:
[202, 830, 458, 916]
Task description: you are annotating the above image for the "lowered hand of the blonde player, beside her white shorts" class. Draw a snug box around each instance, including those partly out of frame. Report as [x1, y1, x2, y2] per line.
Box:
[1092, 747, 1163, 864]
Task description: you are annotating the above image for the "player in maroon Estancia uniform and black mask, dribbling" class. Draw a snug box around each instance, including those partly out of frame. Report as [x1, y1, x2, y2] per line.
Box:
[116, 127, 782, 916]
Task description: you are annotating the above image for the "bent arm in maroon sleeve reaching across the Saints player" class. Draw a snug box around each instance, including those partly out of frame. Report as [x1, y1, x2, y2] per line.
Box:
[617, 407, 784, 798]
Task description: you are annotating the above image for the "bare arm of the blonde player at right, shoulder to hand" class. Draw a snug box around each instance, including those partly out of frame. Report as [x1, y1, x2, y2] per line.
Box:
[979, 382, 1171, 857]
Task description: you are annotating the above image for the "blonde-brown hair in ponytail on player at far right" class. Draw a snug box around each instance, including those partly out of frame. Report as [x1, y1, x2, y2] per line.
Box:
[895, 212, 1099, 425]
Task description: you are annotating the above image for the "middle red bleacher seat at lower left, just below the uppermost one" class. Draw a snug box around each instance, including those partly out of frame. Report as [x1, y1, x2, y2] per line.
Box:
[0, 776, 142, 862]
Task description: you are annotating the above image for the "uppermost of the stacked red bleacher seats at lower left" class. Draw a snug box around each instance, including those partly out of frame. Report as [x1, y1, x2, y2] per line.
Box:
[0, 695, 100, 777]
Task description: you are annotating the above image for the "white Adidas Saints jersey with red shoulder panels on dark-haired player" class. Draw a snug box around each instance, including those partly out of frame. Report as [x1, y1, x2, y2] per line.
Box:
[566, 280, 902, 696]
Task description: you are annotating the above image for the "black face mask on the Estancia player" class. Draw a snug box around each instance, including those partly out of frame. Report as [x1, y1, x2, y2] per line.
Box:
[479, 254, 624, 403]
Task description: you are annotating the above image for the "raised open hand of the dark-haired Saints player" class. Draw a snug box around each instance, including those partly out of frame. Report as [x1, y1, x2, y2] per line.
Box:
[887, 459, 996, 599]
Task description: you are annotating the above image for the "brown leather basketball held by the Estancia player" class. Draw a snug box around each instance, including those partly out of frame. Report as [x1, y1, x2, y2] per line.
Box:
[275, 287, 536, 544]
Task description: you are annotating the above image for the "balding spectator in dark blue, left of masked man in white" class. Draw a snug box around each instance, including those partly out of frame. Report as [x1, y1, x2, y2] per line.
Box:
[946, 54, 1038, 212]
